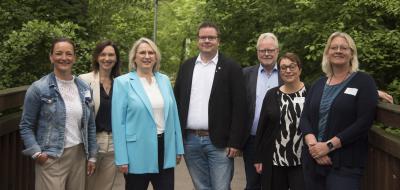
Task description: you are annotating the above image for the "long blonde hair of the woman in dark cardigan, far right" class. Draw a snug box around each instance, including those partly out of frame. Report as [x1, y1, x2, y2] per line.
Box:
[321, 32, 359, 77]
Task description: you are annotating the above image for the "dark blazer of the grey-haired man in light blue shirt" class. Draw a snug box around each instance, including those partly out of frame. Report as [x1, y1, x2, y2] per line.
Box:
[243, 64, 283, 134]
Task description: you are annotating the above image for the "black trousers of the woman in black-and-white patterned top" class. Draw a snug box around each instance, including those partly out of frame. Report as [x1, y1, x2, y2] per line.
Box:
[271, 165, 305, 190]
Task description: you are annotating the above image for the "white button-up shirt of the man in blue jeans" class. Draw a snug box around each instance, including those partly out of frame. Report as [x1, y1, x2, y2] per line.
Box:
[187, 53, 218, 130]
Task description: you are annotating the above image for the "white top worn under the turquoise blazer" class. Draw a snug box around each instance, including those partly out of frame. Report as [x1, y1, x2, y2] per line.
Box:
[140, 76, 165, 134]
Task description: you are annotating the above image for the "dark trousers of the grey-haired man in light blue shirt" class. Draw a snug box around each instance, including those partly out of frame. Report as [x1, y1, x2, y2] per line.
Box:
[243, 135, 261, 190]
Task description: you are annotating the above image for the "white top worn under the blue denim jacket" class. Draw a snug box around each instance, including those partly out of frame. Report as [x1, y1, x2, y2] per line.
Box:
[56, 77, 83, 148]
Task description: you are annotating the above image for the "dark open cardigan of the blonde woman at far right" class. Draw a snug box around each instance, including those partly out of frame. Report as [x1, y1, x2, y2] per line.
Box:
[299, 72, 378, 169]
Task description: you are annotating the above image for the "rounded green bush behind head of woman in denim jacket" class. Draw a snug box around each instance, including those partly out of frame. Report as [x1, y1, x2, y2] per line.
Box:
[0, 20, 92, 89]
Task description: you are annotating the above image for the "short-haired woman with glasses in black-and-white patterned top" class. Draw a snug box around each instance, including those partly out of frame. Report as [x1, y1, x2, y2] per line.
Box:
[254, 53, 306, 190]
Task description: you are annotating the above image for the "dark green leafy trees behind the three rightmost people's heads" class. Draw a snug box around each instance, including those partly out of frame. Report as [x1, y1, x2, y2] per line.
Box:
[206, 0, 400, 88]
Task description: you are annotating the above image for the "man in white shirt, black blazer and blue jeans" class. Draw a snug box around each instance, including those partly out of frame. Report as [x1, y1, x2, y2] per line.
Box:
[174, 23, 248, 190]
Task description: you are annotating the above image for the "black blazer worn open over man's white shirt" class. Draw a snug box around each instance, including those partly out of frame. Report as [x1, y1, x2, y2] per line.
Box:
[174, 54, 248, 149]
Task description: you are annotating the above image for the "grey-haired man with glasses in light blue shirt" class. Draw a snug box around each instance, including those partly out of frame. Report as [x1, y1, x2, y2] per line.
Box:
[243, 33, 282, 190]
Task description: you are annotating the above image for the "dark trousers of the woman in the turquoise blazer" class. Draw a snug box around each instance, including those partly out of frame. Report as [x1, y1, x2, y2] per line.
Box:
[125, 135, 174, 190]
